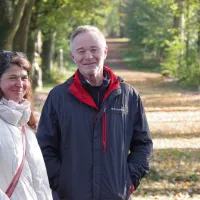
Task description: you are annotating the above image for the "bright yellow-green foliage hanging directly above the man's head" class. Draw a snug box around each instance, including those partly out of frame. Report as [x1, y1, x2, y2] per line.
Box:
[35, 0, 109, 37]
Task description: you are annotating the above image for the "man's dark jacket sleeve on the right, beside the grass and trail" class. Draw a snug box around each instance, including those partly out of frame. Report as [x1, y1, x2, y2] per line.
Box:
[128, 95, 153, 189]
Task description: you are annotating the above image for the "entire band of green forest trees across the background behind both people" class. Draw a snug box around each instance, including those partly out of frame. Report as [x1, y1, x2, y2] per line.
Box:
[0, 0, 200, 87]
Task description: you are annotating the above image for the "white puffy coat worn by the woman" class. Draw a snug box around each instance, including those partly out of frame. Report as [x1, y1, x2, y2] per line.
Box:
[0, 99, 52, 200]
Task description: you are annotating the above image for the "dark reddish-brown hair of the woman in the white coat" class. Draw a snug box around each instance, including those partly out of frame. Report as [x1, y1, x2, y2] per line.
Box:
[0, 51, 37, 130]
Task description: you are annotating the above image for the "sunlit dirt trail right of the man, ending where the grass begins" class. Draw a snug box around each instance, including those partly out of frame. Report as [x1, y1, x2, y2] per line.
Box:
[105, 39, 200, 149]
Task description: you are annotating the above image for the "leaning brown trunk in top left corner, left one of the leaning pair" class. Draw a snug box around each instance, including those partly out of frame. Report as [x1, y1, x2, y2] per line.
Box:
[1, 0, 26, 50]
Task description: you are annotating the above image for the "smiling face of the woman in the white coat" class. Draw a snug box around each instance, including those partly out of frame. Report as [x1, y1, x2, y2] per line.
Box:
[0, 65, 29, 103]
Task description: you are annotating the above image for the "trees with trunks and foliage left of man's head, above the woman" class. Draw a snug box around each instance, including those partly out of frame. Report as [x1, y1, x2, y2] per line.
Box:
[0, 0, 110, 86]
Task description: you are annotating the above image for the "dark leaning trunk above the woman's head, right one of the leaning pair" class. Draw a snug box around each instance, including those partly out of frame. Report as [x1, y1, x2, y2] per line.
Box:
[13, 0, 35, 53]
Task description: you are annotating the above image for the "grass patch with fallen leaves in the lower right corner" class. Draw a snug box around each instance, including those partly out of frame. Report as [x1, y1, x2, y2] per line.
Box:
[134, 148, 200, 200]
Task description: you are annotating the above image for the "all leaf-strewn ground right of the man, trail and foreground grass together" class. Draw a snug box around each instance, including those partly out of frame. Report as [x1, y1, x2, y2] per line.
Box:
[105, 39, 200, 200]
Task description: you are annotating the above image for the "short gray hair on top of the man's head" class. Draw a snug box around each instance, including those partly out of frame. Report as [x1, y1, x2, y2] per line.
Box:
[70, 25, 107, 51]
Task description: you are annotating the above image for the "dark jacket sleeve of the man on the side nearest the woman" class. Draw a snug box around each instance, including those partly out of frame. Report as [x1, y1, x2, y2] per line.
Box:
[36, 92, 61, 190]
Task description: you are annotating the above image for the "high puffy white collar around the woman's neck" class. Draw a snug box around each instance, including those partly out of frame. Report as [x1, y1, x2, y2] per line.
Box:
[0, 98, 31, 126]
